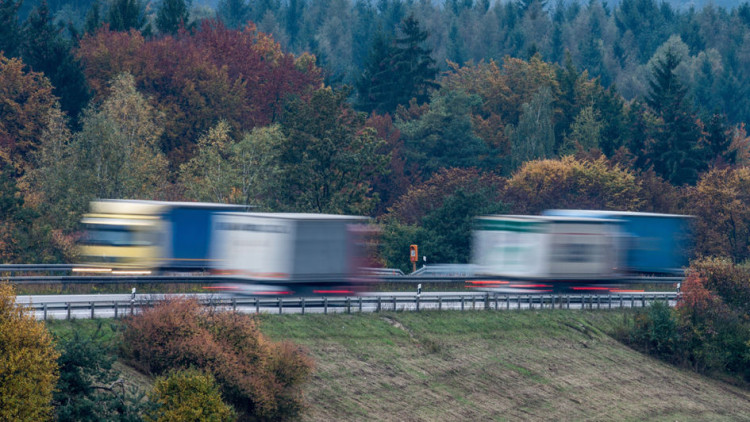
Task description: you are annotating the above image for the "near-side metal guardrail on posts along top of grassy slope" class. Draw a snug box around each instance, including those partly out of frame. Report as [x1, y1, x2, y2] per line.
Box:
[28, 293, 678, 320]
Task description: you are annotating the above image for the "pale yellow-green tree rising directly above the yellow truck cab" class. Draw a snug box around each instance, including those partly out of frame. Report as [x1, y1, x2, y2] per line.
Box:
[30, 74, 166, 216]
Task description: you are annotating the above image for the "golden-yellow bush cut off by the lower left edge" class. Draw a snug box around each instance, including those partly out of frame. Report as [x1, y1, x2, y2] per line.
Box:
[0, 283, 59, 421]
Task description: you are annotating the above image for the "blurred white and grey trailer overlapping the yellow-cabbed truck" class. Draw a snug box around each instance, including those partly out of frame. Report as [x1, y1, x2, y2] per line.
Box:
[212, 213, 368, 295]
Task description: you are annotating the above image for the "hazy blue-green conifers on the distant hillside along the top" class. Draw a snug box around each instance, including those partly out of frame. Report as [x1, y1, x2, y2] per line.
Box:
[10, 0, 750, 122]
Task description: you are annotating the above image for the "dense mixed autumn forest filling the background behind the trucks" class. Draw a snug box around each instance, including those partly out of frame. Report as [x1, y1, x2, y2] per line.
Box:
[0, 0, 750, 266]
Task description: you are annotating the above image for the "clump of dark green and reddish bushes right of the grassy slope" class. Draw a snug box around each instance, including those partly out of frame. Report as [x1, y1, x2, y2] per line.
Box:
[627, 259, 750, 381]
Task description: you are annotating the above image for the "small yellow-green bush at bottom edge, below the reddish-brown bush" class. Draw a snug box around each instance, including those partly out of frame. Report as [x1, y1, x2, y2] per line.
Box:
[144, 369, 235, 422]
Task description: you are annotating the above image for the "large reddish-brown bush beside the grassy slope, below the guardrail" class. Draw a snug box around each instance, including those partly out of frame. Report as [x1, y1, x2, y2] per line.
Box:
[123, 299, 313, 420]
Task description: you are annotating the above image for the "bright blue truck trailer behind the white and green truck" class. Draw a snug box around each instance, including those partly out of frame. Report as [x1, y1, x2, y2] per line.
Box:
[542, 209, 693, 275]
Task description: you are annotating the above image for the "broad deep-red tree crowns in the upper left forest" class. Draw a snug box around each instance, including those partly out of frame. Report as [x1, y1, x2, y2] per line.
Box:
[77, 20, 322, 163]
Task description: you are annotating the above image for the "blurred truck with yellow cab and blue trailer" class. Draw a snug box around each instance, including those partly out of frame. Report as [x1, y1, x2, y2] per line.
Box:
[80, 200, 245, 271]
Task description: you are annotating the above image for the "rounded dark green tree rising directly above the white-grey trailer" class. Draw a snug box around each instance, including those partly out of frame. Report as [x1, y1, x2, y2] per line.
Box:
[278, 88, 389, 214]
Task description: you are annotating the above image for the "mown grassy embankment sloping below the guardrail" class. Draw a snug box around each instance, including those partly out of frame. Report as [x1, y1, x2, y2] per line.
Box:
[45, 310, 750, 421]
